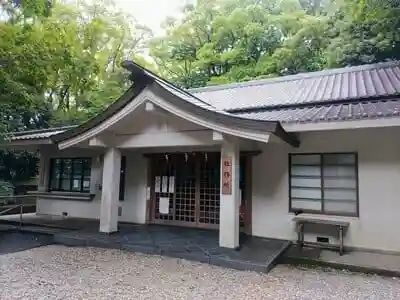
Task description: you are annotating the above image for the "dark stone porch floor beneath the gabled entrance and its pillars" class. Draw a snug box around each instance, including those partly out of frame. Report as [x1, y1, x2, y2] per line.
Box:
[0, 214, 290, 272]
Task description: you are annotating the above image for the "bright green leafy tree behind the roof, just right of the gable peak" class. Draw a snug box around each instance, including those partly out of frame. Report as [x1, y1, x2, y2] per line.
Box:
[150, 0, 325, 87]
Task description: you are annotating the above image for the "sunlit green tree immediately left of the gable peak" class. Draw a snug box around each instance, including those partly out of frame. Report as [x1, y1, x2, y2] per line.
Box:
[44, 1, 151, 124]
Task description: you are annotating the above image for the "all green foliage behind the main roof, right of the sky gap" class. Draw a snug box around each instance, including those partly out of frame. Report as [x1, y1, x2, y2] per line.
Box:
[150, 0, 400, 88]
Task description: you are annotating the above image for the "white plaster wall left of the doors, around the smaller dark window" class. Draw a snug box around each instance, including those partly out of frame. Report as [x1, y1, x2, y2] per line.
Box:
[37, 149, 147, 223]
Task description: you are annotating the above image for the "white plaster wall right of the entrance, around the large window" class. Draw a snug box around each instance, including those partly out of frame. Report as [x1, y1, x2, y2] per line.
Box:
[252, 128, 400, 251]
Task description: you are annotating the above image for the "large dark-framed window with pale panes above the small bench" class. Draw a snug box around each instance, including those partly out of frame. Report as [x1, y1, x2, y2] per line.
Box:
[289, 153, 358, 216]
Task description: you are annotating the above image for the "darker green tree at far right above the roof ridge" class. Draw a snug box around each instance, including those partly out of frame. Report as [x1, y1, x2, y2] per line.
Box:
[327, 0, 400, 67]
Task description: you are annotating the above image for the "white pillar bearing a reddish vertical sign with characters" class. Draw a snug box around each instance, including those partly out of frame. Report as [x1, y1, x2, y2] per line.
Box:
[219, 140, 240, 249]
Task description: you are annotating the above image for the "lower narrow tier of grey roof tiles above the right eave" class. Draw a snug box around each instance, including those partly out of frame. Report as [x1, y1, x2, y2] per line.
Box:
[236, 99, 400, 123]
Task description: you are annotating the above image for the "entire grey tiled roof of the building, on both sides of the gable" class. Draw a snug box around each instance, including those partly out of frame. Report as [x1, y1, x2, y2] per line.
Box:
[8, 61, 400, 141]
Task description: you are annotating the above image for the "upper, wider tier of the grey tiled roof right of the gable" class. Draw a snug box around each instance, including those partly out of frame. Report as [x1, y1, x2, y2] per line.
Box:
[189, 61, 400, 111]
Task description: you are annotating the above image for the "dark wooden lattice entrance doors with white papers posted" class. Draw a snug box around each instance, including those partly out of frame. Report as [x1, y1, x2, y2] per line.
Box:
[150, 152, 249, 229]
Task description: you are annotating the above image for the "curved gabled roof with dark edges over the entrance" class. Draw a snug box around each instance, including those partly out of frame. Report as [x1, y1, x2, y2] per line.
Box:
[52, 61, 299, 147]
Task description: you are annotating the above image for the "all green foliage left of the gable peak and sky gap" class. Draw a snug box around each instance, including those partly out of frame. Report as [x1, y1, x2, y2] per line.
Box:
[0, 0, 151, 130]
